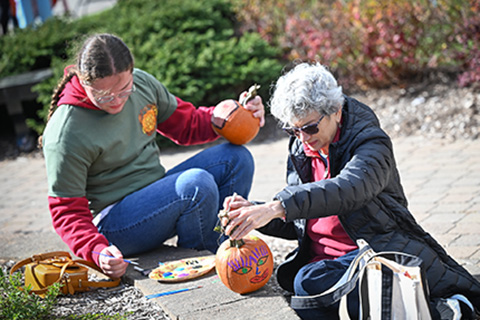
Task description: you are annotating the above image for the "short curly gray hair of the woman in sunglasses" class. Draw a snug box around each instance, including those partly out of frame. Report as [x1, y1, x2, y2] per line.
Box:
[270, 63, 345, 124]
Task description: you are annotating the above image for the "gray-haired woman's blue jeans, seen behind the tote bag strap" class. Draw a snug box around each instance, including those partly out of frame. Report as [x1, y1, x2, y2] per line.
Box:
[294, 249, 359, 320]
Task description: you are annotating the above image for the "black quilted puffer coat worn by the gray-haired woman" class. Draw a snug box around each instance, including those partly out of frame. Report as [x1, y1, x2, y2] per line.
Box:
[260, 97, 480, 310]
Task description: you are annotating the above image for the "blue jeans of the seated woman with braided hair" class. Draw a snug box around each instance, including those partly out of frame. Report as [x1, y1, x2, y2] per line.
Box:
[98, 143, 254, 256]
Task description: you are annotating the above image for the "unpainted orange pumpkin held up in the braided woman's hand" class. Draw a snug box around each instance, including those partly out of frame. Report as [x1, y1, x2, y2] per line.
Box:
[211, 99, 260, 145]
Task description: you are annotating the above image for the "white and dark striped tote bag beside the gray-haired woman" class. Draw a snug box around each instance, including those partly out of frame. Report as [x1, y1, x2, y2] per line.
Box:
[292, 240, 431, 320]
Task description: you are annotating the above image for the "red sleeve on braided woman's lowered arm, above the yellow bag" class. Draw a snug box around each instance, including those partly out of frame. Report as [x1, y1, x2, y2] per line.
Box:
[48, 197, 109, 265]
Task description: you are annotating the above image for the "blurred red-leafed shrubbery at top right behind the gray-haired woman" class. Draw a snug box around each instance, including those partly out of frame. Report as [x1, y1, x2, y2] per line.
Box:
[236, 0, 480, 87]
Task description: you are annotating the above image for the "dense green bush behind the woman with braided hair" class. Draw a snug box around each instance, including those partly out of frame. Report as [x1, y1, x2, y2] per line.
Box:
[0, 0, 282, 140]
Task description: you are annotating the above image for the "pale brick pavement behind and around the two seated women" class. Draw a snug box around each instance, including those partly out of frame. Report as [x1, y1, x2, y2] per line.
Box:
[0, 137, 480, 275]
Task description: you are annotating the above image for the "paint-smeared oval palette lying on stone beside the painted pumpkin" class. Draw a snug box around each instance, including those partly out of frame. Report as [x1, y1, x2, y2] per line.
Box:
[148, 255, 215, 282]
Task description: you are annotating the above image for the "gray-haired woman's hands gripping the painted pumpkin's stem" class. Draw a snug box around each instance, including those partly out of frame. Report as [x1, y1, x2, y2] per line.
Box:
[221, 196, 285, 239]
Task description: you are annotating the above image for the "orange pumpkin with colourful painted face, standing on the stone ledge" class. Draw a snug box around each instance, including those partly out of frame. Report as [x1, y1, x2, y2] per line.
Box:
[215, 235, 273, 294]
